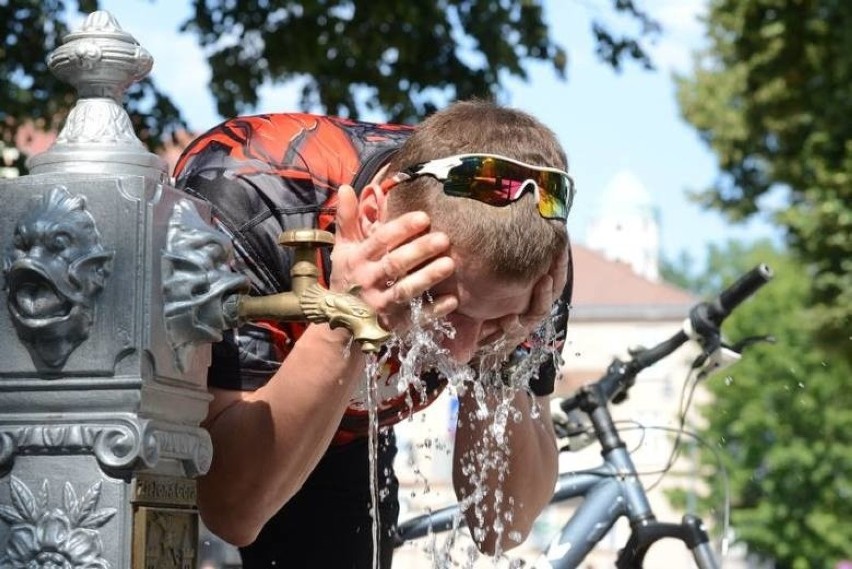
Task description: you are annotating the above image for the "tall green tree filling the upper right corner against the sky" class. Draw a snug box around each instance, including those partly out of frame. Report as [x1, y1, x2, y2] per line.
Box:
[679, 0, 852, 361]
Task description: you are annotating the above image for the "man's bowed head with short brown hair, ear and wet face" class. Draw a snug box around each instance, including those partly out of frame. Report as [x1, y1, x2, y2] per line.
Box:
[362, 101, 568, 362]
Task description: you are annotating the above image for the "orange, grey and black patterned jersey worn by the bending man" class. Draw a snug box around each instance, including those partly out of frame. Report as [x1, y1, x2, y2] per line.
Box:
[175, 113, 570, 443]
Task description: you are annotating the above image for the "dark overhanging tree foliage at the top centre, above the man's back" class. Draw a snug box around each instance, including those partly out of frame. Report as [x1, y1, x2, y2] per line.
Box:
[183, 0, 656, 122]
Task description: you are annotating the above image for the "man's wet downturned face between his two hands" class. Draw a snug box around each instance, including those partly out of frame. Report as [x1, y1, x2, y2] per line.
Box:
[432, 255, 535, 363]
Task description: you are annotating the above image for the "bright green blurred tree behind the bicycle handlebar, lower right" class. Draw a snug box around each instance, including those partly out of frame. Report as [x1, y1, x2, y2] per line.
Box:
[676, 244, 852, 569]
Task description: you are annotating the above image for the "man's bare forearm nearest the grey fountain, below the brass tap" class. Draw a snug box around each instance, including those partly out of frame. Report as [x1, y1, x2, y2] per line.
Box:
[199, 325, 364, 545]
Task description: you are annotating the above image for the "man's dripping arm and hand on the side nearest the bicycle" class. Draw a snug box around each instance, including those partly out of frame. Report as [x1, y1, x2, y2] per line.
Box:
[453, 248, 573, 554]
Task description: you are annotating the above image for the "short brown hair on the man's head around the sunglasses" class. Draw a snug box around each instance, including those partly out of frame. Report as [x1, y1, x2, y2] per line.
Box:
[388, 100, 568, 281]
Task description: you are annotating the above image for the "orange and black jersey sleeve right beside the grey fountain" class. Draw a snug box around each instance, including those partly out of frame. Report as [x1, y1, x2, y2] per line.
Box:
[175, 114, 333, 390]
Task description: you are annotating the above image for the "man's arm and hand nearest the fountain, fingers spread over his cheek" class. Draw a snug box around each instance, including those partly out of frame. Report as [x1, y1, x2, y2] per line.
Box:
[199, 186, 457, 545]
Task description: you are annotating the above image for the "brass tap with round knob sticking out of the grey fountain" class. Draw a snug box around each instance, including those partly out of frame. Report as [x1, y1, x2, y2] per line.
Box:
[225, 229, 390, 353]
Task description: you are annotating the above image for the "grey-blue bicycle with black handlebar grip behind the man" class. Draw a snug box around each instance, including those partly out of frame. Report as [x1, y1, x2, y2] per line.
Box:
[396, 264, 773, 569]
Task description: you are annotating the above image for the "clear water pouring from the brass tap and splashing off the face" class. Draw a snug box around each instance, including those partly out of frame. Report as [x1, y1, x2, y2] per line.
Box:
[365, 299, 561, 569]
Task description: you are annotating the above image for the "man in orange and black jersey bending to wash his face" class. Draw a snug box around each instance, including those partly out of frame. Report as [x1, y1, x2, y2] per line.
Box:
[176, 101, 573, 568]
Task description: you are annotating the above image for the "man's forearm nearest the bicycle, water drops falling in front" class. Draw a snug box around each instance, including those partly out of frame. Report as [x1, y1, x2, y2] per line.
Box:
[453, 390, 558, 554]
